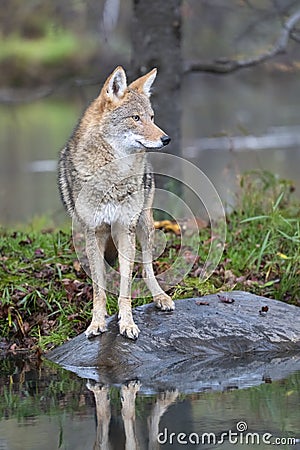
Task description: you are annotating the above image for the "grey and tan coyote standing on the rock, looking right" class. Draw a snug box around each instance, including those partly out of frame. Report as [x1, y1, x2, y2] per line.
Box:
[58, 66, 174, 339]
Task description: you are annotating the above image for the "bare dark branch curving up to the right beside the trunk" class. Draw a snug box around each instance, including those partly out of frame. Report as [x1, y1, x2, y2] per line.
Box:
[184, 10, 300, 74]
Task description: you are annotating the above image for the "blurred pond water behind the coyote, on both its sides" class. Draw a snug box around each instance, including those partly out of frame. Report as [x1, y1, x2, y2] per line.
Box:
[0, 70, 300, 224]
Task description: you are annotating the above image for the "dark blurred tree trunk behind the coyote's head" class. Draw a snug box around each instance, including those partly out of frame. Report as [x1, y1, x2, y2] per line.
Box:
[132, 0, 183, 155]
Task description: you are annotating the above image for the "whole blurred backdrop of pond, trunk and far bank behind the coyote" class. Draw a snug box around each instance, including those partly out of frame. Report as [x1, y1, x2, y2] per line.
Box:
[0, 0, 300, 224]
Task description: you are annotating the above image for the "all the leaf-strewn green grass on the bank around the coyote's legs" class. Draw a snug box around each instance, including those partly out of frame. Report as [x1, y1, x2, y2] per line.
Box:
[0, 173, 300, 350]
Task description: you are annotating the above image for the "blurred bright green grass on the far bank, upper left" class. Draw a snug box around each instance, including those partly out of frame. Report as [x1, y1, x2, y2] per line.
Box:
[0, 26, 101, 88]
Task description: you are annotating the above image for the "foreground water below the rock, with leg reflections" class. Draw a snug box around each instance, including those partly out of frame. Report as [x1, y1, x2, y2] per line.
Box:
[0, 359, 300, 450]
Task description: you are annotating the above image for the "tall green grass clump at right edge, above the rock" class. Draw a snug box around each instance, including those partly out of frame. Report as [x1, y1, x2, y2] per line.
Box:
[226, 172, 300, 304]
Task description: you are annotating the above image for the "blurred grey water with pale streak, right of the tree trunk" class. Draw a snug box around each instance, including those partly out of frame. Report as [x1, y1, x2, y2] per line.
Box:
[183, 70, 300, 209]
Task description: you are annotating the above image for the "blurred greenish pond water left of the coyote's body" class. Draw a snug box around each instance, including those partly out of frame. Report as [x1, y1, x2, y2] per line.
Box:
[0, 99, 80, 224]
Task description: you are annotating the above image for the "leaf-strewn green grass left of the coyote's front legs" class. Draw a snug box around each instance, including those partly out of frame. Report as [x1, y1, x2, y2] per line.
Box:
[0, 230, 91, 347]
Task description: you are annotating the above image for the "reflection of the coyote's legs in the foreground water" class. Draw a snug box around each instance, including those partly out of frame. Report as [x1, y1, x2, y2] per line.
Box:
[87, 381, 178, 450]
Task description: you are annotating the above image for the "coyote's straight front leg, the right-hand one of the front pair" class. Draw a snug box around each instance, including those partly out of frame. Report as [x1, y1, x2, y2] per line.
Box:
[117, 227, 140, 339]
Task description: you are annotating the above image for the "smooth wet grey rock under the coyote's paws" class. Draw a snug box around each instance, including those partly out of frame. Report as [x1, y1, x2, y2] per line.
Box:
[46, 291, 300, 392]
